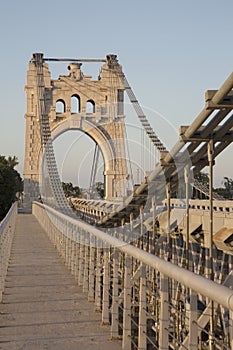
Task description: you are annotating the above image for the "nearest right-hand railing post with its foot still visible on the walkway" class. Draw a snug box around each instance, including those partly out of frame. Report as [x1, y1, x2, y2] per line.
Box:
[111, 248, 119, 339]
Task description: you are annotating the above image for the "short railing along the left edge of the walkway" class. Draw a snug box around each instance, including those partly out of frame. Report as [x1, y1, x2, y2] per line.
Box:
[0, 202, 17, 302]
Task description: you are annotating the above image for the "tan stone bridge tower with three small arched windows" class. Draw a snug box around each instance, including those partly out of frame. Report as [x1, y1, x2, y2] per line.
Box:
[24, 55, 127, 203]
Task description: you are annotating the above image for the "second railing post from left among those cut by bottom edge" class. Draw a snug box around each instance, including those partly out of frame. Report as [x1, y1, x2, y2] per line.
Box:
[138, 265, 147, 350]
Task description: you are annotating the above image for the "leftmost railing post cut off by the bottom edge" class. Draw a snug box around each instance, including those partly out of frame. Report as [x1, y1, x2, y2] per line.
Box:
[122, 255, 131, 350]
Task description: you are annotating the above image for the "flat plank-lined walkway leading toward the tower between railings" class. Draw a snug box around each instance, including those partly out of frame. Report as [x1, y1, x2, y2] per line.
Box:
[0, 214, 121, 350]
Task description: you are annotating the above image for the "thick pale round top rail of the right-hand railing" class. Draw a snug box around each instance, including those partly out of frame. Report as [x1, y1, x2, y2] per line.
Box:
[33, 202, 233, 311]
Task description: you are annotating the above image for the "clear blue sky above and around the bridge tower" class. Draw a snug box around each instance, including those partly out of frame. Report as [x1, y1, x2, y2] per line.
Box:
[0, 0, 233, 187]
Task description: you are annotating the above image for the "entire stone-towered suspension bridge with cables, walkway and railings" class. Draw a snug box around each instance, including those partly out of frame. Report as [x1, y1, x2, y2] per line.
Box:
[0, 53, 233, 350]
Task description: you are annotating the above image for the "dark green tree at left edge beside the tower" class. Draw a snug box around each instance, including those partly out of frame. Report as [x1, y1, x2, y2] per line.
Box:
[0, 155, 23, 220]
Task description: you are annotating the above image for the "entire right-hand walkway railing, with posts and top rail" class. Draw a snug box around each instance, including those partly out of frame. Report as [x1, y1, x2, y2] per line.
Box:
[33, 202, 233, 350]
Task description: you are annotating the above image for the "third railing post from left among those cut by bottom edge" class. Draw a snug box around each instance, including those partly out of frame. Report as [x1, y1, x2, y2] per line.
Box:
[159, 274, 169, 350]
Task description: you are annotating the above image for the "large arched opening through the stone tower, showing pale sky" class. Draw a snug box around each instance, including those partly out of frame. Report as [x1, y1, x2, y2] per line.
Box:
[53, 130, 105, 199]
